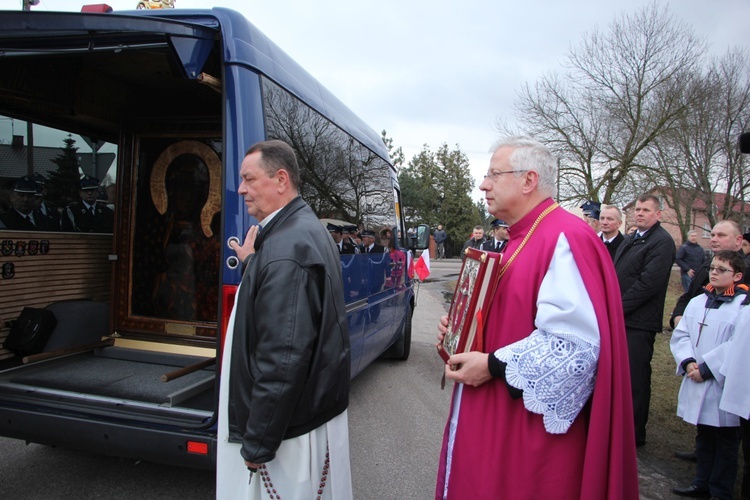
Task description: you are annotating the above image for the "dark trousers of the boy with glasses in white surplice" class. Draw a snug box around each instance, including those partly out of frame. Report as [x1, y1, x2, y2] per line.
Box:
[693, 424, 740, 500]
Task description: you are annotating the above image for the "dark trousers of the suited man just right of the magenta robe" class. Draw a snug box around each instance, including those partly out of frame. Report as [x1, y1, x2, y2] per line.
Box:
[625, 327, 656, 445]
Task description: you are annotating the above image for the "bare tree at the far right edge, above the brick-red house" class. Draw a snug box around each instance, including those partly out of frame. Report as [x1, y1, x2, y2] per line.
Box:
[647, 49, 750, 238]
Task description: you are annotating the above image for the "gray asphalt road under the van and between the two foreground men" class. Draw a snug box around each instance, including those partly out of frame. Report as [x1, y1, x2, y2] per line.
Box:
[0, 261, 460, 500]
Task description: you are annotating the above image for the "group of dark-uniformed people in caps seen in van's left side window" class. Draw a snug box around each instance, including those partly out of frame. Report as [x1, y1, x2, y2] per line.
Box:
[0, 173, 114, 233]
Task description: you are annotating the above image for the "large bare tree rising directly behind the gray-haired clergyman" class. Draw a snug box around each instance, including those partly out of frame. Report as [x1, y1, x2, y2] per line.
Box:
[499, 3, 706, 203]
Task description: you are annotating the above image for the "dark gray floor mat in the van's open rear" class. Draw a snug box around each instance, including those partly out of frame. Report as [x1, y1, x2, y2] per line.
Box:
[11, 357, 214, 404]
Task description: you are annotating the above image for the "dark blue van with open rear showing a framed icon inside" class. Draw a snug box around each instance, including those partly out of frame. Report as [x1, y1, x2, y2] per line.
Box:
[0, 8, 429, 469]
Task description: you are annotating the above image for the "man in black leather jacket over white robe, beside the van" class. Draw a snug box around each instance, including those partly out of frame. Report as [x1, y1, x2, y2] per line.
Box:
[219, 141, 351, 498]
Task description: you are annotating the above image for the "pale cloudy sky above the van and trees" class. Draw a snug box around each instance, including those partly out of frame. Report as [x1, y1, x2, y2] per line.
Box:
[0, 0, 750, 198]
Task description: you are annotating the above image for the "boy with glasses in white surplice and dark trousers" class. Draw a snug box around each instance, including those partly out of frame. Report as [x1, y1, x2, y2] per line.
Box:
[670, 250, 748, 499]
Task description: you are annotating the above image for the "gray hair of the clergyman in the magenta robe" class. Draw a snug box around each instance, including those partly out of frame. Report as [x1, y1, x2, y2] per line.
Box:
[490, 135, 557, 200]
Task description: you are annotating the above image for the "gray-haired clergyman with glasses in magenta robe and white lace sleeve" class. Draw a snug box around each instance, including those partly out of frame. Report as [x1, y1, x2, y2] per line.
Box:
[435, 137, 638, 499]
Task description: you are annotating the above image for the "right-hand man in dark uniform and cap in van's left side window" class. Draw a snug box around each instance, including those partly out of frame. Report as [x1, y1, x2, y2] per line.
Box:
[62, 175, 115, 233]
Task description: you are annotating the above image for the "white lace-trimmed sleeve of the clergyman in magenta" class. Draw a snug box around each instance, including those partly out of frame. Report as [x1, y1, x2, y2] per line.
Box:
[494, 234, 604, 434]
